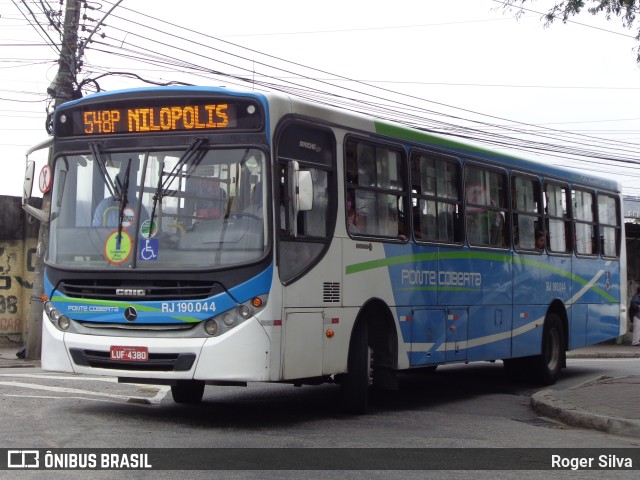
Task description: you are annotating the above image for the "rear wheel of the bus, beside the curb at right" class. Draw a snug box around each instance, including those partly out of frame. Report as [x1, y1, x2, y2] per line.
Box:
[530, 313, 565, 385]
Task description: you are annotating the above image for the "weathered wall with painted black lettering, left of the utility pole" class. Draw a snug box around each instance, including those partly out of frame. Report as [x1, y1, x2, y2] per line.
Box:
[0, 195, 40, 346]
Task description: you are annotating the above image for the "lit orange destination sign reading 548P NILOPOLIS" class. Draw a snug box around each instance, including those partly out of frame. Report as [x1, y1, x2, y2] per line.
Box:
[56, 99, 262, 137]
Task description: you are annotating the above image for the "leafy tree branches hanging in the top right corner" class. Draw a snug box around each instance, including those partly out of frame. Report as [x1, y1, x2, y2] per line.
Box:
[503, 0, 640, 63]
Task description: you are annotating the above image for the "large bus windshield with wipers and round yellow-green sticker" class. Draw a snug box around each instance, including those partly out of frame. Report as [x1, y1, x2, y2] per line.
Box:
[47, 144, 269, 270]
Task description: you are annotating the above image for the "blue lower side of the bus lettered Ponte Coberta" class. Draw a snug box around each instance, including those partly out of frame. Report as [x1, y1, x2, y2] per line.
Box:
[370, 244, 621, 365]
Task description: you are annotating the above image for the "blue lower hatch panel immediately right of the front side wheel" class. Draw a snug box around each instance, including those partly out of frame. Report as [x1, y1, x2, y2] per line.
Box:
[409, 309, 446, 366]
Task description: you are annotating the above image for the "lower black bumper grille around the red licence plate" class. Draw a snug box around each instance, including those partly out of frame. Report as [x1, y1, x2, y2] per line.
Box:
[69, 348, 196, 372]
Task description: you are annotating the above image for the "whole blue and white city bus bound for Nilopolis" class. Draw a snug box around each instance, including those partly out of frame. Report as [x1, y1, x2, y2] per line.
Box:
[25, 87, 626, 412]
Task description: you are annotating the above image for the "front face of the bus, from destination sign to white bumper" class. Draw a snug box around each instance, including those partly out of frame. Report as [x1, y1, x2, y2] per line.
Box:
[42, 91, 279, 399]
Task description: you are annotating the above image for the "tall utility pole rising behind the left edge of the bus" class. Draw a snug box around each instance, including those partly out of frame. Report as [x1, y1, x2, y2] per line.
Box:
[25, 0, 81, 360]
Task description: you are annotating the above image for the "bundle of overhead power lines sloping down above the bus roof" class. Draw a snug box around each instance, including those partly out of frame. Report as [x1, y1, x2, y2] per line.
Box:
[3, 0, 640, 191]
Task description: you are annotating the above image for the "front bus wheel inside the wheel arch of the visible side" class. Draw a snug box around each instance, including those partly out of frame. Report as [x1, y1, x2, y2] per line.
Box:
[340, 322, 371, 414]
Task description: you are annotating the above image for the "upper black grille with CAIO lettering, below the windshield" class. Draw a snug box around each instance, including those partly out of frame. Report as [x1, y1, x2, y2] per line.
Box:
[58, 280, 223, 301]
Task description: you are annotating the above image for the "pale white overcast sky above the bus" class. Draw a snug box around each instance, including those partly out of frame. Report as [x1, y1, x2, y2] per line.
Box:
[0, 0, 640, 196]
